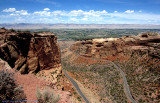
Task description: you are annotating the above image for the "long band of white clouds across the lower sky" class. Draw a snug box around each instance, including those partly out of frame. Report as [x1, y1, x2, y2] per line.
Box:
[0, 8, 160, 24]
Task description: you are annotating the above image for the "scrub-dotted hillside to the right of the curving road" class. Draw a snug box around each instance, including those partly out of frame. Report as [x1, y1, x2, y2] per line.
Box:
[117, 51, 160, 103]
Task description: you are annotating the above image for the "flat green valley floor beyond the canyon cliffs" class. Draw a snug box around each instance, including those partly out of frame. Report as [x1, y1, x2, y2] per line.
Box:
[17, 29, 160, 40]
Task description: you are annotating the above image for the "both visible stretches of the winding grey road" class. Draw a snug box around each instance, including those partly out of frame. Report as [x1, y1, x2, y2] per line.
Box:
[63, 46, 137, 103]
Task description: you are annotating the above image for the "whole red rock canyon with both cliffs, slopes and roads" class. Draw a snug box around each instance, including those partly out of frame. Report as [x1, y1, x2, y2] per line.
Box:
[0, 28, 160, 103]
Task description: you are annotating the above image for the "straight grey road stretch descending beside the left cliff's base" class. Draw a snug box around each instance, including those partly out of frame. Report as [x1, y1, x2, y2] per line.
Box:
[62, 70, 89, 103]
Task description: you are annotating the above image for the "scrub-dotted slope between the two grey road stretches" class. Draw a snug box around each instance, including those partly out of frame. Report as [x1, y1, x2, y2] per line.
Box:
[62, 57, 127, 103]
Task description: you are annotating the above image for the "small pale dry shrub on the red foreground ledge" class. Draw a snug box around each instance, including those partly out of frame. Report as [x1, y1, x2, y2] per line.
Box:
[36, 88, 60, 103]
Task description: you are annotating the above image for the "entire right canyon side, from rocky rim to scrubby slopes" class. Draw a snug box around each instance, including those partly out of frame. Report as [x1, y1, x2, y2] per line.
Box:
[64, 32, 160, 103]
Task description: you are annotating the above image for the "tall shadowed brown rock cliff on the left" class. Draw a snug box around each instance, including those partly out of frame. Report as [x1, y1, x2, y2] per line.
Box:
[0, 29, 61, 74]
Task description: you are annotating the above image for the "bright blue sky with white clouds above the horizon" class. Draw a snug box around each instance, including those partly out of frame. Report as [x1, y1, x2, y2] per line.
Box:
[0, 0, 160, 25]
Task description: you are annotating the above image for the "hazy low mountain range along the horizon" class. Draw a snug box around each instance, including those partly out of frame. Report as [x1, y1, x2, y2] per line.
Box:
[0, 23, 160, 29]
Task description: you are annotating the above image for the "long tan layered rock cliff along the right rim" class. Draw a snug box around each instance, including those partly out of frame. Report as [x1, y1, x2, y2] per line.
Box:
[70, 33, 160, 58]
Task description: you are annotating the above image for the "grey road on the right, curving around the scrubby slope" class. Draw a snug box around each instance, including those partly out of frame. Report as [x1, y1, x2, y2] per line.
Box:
[69, 49, 137, 103]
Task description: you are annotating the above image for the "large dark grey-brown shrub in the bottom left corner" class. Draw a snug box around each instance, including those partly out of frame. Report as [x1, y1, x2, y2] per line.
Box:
[0, 70, 26, 102]
